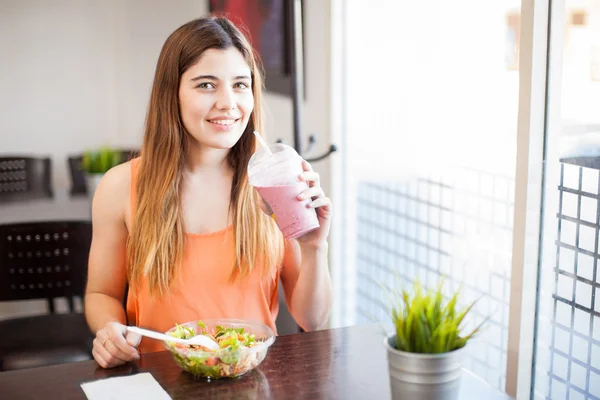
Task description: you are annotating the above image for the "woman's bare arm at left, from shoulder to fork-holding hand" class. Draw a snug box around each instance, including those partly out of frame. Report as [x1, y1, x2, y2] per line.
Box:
[84, 163, 139, 368]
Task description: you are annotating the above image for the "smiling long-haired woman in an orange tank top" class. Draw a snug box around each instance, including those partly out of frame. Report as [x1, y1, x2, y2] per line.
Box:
[85, 17, 332, 368]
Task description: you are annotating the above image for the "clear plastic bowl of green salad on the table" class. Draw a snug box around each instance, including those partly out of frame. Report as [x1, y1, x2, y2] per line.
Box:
[163, 319, 275, 379]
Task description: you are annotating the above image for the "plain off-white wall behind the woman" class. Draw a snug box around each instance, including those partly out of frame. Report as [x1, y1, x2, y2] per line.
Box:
[0, 0, 330, 318]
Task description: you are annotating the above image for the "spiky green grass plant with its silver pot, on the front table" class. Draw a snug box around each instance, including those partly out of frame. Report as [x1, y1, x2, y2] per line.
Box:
[384, 281, 485, 400]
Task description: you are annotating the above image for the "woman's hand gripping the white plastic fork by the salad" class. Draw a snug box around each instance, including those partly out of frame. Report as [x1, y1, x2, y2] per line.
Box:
[92, 322, 142, 368]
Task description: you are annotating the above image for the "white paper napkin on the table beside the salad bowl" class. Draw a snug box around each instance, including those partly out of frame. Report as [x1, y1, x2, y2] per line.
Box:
[81, 372, 171, 400]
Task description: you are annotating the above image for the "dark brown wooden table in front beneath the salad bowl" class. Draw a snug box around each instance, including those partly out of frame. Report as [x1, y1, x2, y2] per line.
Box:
[0, 325, 510, 400]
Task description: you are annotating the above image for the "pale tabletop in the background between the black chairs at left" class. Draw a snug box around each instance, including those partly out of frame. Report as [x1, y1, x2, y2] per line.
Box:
[0, 190, 92, 224]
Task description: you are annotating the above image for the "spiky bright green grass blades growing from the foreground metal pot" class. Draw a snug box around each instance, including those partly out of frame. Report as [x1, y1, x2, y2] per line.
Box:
[391, 281, 485, 354]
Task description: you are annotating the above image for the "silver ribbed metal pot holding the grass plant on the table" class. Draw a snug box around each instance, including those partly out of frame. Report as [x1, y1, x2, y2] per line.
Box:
[383, 335, 464, 400]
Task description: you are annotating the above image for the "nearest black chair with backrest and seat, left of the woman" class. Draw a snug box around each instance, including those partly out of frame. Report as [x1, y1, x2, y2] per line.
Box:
[0, 221, 94, 371]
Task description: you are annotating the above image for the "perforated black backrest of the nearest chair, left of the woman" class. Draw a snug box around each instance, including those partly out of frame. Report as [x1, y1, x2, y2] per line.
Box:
[0, 221, 92, 312]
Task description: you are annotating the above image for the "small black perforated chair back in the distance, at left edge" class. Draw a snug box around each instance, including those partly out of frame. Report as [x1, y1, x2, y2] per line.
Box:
[0, 156, 52, 202]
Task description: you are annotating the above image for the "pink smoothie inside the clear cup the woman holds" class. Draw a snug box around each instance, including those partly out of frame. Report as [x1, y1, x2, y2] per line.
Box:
[256, 181, 319, 239]
